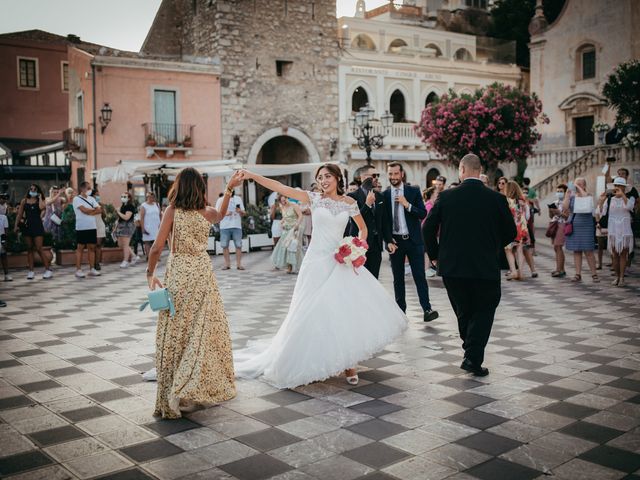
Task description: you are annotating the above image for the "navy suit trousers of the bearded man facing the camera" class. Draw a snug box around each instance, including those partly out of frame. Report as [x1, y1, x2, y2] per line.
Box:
[389, 235, 431, 312]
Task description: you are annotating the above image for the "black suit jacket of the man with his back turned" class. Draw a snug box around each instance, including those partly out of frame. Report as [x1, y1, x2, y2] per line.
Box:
[423, 179, 517, 280]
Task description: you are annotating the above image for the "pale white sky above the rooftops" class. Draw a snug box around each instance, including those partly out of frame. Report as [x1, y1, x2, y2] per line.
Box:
[0, 0, 388, 51]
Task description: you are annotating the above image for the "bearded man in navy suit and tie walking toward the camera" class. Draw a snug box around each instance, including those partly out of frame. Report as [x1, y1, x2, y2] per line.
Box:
[384, 162, 438, 322]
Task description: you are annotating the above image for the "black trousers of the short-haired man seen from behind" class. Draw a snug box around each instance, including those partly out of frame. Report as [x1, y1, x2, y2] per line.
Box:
[442, 277, 501, 365]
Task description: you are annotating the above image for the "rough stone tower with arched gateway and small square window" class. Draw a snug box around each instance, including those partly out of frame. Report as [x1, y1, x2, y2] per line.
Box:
[142, 0, 339, 201]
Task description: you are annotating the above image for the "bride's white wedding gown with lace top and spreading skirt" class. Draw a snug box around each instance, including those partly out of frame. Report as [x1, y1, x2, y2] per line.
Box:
[234, 192, 407, 388]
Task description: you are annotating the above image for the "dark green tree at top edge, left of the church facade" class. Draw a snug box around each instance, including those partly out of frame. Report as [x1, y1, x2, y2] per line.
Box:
[488, 0, 565, 67]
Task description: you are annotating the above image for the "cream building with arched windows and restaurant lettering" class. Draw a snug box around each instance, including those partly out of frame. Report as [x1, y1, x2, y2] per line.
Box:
[338, 0, 523, 187]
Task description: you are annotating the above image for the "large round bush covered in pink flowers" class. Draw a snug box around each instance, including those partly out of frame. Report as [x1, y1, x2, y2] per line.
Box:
[416, 83, 549, 173]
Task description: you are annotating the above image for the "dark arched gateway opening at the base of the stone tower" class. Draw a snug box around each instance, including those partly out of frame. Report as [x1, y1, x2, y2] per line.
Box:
[256, 135, 309, 205]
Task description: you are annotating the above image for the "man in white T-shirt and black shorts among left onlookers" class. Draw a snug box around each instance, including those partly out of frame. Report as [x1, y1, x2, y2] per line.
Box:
[73, 182, 102, 278]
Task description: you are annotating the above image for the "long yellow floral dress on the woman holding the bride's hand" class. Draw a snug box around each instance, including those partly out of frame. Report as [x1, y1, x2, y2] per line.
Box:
[154, 209, 236, 418]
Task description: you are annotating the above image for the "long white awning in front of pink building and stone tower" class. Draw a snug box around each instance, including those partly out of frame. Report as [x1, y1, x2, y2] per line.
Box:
[96, 160, 338, 185]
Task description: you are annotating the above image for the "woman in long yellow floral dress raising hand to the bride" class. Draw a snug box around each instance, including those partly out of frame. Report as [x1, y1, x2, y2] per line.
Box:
[147, 168, 242, 418]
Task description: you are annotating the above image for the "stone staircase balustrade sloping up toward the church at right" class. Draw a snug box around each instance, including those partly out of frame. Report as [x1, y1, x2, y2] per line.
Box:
[533, 145, 640, 198]
